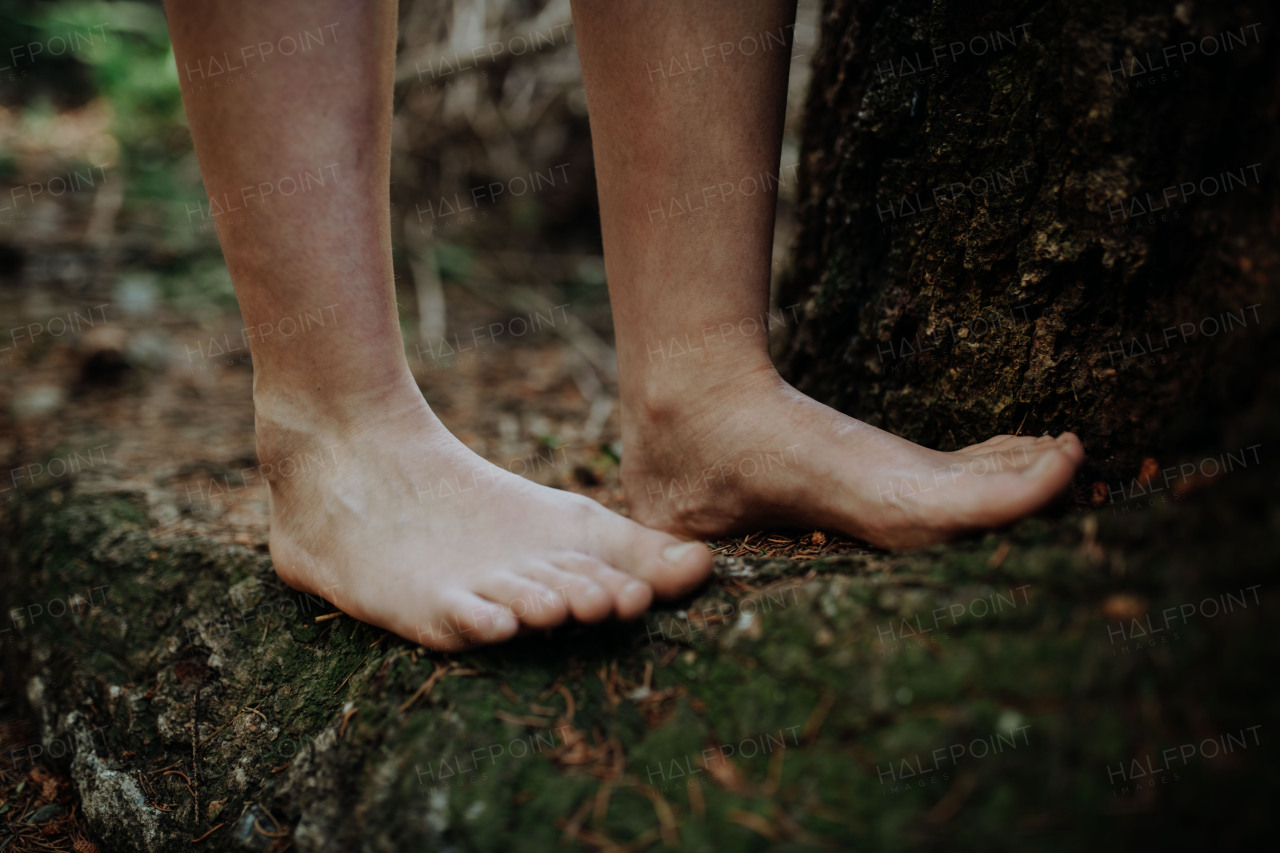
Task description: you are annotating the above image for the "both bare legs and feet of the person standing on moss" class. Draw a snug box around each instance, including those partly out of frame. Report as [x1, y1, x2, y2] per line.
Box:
[157, 0, 1083, 649]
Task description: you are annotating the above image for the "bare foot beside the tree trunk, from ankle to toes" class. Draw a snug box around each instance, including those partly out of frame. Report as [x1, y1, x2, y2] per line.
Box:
[622, 366, 1084, 548]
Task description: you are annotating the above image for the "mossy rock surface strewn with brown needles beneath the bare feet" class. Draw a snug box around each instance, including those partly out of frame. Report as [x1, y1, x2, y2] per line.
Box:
[4, 465, 1280, 852]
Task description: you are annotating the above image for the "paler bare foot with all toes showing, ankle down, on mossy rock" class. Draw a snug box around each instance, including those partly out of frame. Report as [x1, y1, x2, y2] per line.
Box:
[257, 388, 712, 651]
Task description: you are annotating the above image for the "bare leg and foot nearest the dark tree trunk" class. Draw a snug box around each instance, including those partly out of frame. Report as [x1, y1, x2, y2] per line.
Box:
[573, 0, 1084, 547]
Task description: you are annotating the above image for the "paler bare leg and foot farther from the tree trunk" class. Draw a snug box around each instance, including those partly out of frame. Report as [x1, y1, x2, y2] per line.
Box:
[166, 0, 710, 648]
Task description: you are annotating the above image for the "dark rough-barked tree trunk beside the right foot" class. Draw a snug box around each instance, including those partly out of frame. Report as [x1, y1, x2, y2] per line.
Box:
[782, 0, 1280, 476]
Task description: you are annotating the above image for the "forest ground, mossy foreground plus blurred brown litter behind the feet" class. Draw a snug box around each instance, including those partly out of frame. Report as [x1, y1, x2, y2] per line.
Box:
[0, 257, 1280, 852]
